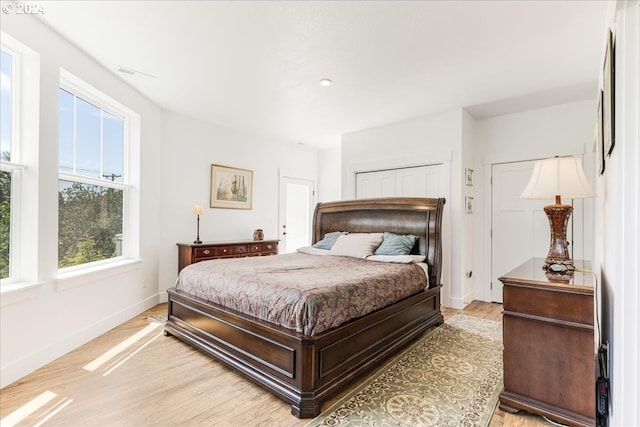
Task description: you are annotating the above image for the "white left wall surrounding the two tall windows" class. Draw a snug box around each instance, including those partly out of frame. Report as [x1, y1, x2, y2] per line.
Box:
[0, 14, 162, 386]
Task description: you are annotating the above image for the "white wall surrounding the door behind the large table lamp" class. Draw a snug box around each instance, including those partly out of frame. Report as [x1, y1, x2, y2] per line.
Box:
[473, 99, 597, 301]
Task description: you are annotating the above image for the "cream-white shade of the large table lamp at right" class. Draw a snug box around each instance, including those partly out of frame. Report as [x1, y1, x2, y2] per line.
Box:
[520, 157, 596, 199]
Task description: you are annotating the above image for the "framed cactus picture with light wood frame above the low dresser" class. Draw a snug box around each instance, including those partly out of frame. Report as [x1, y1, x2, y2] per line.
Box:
[210, 164, 253, 209]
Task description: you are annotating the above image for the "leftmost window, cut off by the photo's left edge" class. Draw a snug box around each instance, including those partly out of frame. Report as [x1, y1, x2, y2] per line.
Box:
[0, 33, 40, 285]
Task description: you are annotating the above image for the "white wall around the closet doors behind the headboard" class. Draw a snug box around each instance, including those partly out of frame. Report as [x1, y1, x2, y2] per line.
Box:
[342, 110, 466, 308]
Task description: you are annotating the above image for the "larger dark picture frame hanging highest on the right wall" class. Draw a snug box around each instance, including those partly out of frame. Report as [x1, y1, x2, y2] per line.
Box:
[602, 30, 615, 156]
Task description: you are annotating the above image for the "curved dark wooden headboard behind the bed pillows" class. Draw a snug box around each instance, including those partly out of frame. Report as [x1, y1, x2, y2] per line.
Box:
[313, 197, 445, 287]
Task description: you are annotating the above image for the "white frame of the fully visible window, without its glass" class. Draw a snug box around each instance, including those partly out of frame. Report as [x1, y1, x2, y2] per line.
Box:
[58, 69, 140, 278]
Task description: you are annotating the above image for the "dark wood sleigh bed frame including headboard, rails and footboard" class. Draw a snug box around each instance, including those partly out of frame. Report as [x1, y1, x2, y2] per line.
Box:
[165, 198, 445, 418]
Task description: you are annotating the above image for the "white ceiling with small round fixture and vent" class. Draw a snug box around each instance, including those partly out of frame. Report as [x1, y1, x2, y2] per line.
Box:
[36, 0, 608, 148]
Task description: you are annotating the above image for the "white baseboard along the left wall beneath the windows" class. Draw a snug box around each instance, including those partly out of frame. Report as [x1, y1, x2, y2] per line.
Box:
[0, 294, 160, 388]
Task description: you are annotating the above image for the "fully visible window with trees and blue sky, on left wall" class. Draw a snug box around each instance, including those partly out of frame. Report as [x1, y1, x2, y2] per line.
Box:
[58, 73, 129, 268]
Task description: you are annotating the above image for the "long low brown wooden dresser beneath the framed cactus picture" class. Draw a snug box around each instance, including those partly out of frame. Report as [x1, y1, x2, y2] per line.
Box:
[177, 240, 278, 272]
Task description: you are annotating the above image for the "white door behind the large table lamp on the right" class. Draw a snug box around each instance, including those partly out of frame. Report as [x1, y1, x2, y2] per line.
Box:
[491, 161, 584, 302]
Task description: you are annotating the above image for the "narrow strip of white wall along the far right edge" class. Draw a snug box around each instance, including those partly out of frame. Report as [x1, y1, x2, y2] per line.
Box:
[596, 1, 640, 426]
